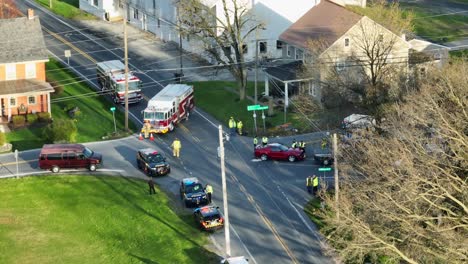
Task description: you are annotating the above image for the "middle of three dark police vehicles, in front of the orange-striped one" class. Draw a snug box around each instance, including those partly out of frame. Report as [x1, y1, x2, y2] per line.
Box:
[180, 177, 208, 207]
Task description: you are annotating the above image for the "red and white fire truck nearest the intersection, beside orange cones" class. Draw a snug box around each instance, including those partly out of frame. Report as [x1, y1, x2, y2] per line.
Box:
[141, 84, 195, 136]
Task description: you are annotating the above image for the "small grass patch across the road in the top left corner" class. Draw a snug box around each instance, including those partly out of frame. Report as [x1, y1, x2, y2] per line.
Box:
[36, 0, 96, 19]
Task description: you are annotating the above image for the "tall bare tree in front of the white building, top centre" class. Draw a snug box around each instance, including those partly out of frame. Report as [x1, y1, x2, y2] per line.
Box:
[178, 0, 263, 100]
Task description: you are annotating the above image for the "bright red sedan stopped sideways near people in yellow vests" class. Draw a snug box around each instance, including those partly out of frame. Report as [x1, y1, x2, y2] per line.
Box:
[254, 143, 305, 162]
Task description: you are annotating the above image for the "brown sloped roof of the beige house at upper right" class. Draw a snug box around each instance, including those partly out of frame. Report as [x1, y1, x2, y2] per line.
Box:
[279, 0, 362, 48]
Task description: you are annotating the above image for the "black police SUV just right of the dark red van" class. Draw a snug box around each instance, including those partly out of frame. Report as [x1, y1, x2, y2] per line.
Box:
[136, 148, 171, 176]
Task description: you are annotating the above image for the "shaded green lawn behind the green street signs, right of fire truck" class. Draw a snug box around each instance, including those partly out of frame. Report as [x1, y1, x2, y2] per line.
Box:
[192, 81, 308, 135]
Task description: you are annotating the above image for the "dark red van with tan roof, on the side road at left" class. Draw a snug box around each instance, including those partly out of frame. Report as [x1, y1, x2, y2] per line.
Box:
[39, 144, 102, 173]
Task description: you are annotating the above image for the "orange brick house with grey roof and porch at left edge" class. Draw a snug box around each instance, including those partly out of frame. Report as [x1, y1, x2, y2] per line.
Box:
[0, 9, 54, 122]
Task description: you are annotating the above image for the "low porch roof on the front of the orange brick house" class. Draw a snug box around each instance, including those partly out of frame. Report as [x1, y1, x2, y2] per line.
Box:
[0, 79, 54, 95]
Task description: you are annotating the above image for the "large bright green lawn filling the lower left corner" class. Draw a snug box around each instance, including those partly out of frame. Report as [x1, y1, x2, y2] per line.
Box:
[0, 176, 219, 264]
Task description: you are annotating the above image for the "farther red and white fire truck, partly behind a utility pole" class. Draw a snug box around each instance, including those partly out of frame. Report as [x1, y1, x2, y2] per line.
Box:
[96, 60, 143, 104]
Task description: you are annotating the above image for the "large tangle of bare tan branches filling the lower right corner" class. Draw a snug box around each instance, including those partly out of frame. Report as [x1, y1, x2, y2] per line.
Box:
[322, 61, 468, 263]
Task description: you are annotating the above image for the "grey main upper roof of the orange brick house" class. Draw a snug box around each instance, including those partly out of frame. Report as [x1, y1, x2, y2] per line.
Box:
[0, 17, 48, 64]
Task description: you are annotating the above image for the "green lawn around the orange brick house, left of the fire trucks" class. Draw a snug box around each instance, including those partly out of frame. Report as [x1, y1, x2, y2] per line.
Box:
[6, 60, 135, 150]
